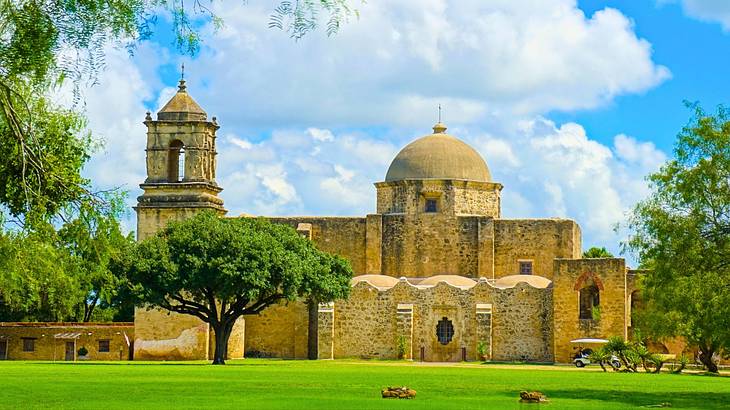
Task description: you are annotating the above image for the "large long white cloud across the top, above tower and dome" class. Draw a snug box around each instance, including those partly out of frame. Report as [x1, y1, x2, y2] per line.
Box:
[189, 0, 670, 127]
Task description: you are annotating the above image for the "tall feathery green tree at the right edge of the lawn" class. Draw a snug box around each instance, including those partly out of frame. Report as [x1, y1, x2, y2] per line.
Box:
[626, 105, 730, 372]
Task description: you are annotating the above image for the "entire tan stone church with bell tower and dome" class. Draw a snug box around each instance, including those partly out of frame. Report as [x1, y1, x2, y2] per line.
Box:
[134, 81, 636, 362]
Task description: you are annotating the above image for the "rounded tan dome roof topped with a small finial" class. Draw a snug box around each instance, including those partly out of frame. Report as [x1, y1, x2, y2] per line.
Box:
[385, 123, 492, 182]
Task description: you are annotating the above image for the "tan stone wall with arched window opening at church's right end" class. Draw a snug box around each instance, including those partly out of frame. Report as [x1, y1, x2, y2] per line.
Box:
[553, 258, 628, 362]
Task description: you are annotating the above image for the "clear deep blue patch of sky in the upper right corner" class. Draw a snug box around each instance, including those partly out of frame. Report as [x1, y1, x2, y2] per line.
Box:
[564, 0, 730, 153]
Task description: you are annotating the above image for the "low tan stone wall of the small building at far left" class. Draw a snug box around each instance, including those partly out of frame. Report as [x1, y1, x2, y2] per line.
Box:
[0, 322, 134, 360]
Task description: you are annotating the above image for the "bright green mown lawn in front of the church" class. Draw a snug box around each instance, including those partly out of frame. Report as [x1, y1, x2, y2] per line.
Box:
[0, 359, 730, 410]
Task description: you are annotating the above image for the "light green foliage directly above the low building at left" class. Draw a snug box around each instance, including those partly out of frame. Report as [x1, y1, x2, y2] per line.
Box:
[0, 197, 133, 322]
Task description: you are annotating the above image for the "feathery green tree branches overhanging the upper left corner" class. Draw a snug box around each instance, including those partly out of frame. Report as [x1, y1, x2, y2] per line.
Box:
[0, 0, 357, 217]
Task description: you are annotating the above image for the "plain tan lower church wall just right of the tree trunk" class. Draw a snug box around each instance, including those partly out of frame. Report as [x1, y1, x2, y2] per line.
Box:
[245, 301, 309, 359]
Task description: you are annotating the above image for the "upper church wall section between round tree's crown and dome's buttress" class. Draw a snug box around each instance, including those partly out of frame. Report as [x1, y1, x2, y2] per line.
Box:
[267, 216, 367, 275]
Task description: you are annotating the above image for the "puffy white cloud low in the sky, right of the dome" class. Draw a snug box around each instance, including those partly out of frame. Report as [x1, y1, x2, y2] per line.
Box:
[464, 117, 666, 252]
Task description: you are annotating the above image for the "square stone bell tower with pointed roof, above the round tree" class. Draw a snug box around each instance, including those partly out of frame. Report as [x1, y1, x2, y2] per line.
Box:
[135, 79, 226, 241]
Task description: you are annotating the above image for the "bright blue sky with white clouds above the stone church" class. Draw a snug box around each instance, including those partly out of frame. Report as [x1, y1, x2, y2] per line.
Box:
[75, 0, 730, 266]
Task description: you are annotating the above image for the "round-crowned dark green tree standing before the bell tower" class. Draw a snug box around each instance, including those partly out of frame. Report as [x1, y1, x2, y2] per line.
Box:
[123, 212, 352, 364]
